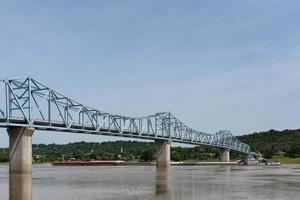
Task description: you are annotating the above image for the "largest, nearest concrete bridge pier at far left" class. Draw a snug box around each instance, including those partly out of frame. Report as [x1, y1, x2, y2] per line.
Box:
[7, 127, 34, 173]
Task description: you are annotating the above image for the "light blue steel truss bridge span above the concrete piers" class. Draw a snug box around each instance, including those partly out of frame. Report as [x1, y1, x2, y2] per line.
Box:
[0, 77, 250, 154]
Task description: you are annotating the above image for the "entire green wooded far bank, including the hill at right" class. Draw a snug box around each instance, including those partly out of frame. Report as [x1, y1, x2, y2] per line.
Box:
[0, 130, 300, 162]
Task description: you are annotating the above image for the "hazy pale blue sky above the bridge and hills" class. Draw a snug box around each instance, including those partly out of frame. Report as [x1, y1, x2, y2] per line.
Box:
[0, 0, 300, 146]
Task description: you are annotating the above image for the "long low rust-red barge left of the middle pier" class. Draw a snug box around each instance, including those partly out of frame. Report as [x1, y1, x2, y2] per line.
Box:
[51, 160, 124, 166]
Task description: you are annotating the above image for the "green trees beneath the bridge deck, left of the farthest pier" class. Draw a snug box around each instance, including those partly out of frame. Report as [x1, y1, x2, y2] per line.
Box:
[0, 141, 223, 162]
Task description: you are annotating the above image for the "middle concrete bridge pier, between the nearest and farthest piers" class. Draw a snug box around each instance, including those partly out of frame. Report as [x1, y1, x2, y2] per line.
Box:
[155, 140, 171, 168]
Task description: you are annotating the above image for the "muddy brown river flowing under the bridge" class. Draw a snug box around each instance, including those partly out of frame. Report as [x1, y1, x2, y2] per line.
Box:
[0, 165, 300, 200]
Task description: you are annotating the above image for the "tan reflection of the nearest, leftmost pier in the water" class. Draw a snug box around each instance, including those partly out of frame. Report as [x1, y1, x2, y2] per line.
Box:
[9, 173, 32, 200]
